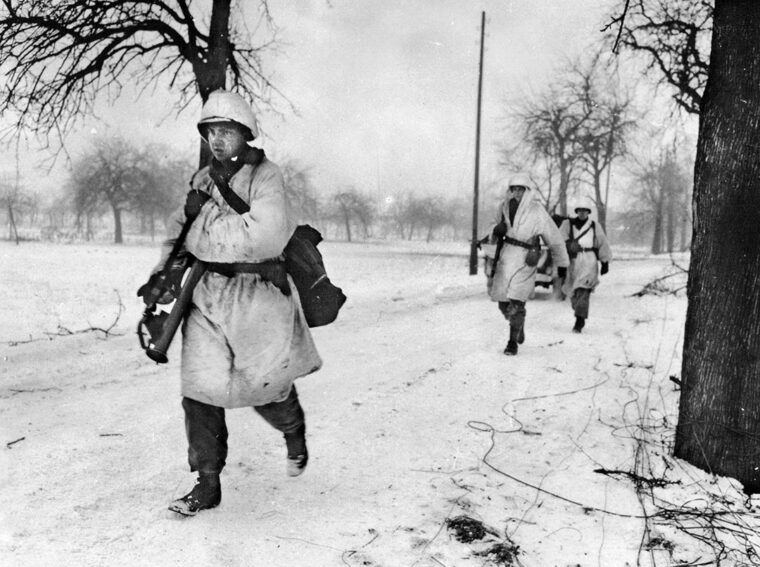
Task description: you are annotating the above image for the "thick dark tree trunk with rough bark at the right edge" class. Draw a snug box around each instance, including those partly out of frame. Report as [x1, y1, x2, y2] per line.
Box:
[675, 0, 760, 493]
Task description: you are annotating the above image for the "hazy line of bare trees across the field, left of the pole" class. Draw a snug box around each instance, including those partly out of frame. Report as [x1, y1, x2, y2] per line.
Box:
[0, 136, 480, 244]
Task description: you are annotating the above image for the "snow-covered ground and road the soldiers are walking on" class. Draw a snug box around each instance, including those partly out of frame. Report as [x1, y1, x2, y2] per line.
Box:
[0, 242, 760, 567]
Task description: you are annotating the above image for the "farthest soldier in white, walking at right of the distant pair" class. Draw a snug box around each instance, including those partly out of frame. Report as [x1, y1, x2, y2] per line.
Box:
[560, 204, 612, 333]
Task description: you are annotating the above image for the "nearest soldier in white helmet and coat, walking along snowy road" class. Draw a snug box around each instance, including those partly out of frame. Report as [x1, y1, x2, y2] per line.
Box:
[142, 91, 322, 516]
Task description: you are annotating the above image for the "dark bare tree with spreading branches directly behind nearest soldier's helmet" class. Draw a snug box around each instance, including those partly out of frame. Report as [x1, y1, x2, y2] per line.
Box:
[0, 0, 284, 163]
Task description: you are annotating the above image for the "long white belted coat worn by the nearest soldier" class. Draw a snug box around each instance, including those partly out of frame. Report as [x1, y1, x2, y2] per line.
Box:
[159, 158, 322, 408]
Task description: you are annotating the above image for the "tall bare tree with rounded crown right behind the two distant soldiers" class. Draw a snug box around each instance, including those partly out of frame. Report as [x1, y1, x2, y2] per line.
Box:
[501, 52, 635, 222]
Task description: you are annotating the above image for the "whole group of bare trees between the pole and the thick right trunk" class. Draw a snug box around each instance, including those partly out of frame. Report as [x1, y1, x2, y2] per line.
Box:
[492, 48, 693, 254]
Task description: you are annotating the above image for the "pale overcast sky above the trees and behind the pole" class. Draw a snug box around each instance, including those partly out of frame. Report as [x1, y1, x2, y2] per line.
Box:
[2, 0, 617, 204]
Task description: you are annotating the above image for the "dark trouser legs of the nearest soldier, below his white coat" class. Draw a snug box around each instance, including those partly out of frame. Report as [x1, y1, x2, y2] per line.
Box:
[182, 386, 305, 473]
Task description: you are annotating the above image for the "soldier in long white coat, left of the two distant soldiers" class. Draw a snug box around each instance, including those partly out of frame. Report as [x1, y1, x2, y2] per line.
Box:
[488, 173, 568, 355]
